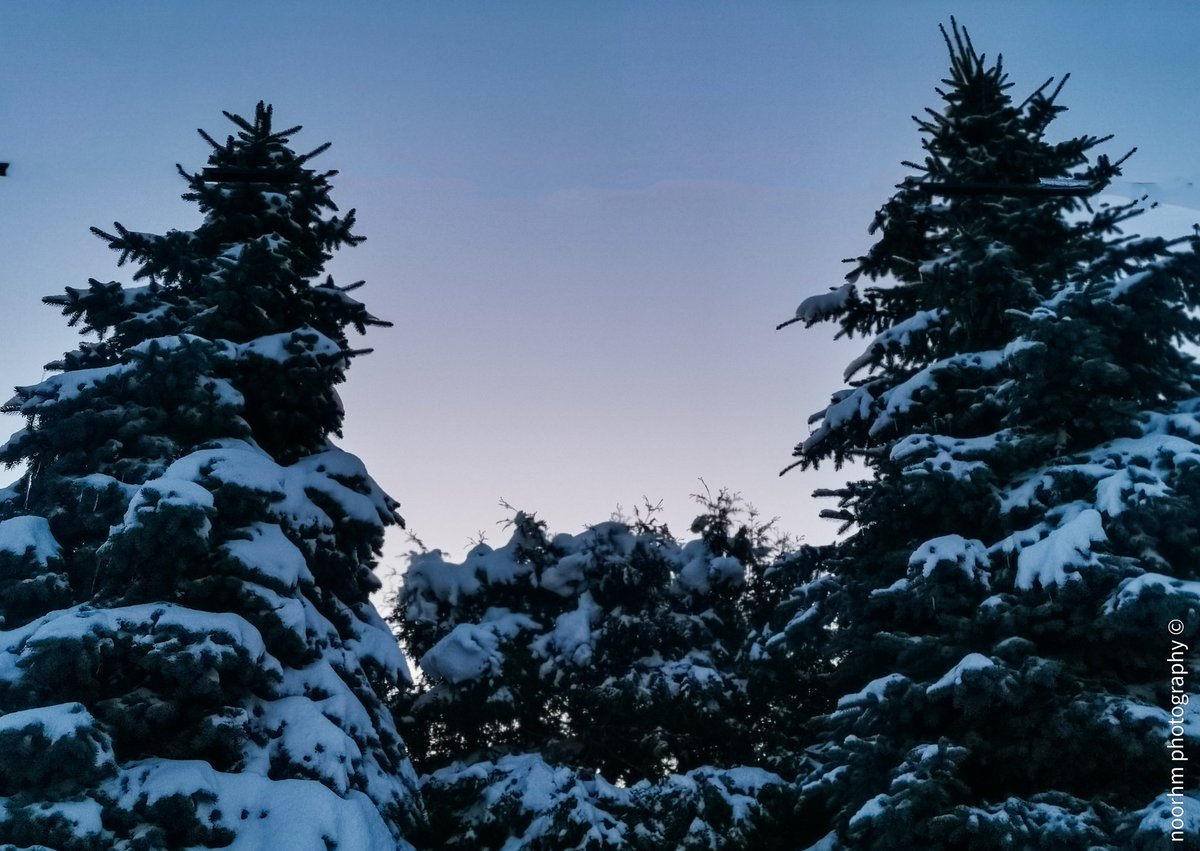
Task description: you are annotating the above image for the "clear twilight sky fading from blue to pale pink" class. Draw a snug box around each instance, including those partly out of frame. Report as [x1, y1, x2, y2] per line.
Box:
[0, 0, 1200, 578]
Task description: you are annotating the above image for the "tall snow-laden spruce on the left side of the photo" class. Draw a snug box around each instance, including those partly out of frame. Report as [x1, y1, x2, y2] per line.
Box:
[0, 103, 424, 851]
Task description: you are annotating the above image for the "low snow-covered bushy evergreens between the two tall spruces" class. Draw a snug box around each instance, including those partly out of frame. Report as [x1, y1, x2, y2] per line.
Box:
[396, 491, 794, 851]
